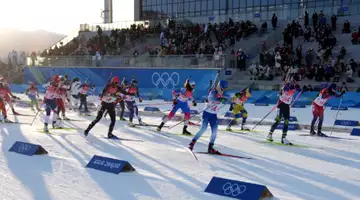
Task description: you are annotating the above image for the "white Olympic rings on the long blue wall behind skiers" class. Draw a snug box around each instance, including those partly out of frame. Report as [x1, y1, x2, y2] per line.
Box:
[151, 72, 180, 89]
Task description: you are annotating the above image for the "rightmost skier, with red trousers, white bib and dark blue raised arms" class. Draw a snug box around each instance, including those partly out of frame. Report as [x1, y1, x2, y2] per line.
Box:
[310, 83, 345, 137]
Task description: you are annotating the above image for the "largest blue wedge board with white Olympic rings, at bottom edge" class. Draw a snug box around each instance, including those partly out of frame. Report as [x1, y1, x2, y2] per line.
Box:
[205, 176, 273, 200]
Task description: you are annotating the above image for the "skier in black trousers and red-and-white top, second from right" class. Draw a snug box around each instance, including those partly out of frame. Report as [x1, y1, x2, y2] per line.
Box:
[267, 81, 296, 145]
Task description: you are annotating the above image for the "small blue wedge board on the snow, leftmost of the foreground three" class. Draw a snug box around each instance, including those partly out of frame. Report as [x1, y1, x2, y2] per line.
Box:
[9, 141, 48, 156]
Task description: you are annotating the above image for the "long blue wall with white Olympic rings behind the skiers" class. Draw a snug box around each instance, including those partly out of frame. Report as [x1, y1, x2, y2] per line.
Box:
[21, 67, 217, 99]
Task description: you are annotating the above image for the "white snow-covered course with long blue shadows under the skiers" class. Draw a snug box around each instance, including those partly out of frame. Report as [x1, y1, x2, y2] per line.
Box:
[0, 95, 360, 200]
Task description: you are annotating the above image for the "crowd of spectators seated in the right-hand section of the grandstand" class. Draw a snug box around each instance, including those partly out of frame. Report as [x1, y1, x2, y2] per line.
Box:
[243, 12, 360, 82]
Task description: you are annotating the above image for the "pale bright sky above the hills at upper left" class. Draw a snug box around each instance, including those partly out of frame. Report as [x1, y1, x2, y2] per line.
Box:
[0, 0, 134, 34]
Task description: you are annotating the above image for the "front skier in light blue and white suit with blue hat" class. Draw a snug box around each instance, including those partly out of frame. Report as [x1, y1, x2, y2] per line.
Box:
[189, 80, 228, 154]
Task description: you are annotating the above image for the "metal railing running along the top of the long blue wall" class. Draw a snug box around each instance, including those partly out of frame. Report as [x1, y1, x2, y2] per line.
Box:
[26, 55, 227, 68]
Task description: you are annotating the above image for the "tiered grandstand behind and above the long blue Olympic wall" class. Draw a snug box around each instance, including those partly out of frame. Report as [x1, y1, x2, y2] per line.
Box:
[17, 1, 359, 90]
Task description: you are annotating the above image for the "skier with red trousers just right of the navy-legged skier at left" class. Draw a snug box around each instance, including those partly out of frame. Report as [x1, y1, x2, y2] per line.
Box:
[56, 76, 70, 120]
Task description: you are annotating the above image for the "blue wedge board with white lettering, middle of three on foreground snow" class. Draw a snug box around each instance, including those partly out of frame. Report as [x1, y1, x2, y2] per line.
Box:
[86, 155, 135, 174]
